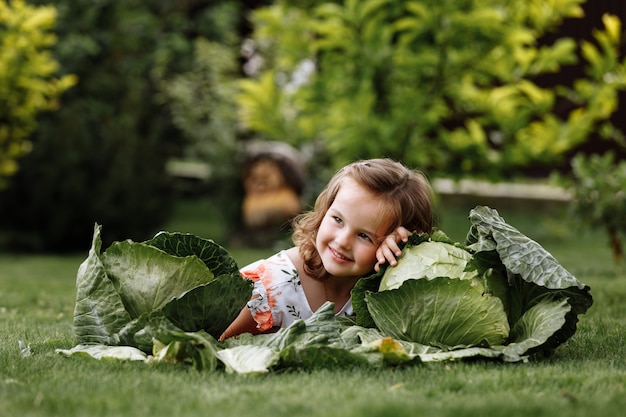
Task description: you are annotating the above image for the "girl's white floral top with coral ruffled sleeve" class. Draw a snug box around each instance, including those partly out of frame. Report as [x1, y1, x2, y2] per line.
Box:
[241, 251, 353, 332]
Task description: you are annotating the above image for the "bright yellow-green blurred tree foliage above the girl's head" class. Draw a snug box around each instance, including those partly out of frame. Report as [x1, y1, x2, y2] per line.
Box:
[239, 0, 626, 178]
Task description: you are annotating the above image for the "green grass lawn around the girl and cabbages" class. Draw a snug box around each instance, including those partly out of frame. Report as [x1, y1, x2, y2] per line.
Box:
[0, 202, 626, 417]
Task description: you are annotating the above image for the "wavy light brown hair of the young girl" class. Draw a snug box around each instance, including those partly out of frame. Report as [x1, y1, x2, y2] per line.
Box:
[292, 158, 434, 279]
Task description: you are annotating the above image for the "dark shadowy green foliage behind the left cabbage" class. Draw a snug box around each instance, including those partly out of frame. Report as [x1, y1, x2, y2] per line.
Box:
[0, 0, 247, 251]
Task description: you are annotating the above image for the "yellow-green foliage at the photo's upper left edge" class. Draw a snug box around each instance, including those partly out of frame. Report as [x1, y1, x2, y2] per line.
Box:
[0, 0, 76, 188]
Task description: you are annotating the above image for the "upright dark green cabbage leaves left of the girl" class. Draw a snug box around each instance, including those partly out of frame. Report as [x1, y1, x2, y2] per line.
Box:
[74, 224, 252, 352]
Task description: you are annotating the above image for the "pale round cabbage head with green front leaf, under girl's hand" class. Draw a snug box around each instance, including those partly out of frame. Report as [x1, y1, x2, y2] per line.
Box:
[365, 236, 509, 348]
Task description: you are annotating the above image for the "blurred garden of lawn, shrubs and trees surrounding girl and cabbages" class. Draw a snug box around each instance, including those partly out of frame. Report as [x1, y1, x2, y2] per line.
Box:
[0, 0, 626, 416]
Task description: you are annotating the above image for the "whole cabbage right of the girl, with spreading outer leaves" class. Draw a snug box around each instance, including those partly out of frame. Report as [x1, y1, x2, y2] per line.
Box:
[353, 206, 592, 361]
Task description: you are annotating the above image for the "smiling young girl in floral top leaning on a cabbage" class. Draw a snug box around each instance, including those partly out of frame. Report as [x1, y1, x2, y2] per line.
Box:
[220, 159, 433, 340]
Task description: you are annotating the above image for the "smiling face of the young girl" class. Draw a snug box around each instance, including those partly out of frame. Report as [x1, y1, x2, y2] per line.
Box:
[315, 178, 391, 277]
